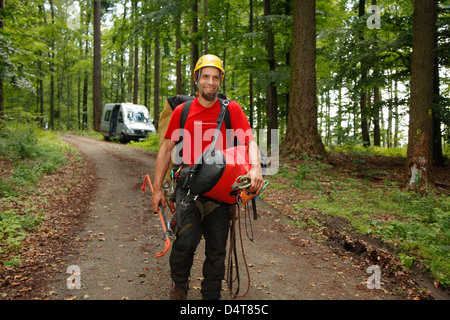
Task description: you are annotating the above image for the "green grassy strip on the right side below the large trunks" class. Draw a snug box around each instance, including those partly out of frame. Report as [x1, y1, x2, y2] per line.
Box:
[269, 152, 450, 287]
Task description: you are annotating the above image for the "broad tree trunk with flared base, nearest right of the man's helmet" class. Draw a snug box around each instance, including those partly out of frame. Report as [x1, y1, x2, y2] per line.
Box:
[281, 0, 326, 157]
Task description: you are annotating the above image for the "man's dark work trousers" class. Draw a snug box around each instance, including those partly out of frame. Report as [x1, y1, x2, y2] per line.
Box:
[170, 189, 230, 299]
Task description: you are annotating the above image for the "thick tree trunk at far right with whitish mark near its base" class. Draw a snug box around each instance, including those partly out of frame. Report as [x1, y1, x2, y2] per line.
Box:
[406, 0, 436, 191]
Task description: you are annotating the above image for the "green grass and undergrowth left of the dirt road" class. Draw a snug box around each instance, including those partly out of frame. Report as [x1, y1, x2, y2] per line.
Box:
[0, 122, 72, 265]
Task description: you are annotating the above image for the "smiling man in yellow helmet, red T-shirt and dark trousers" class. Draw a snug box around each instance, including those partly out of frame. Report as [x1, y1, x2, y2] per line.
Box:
[152, 55, 264, 300]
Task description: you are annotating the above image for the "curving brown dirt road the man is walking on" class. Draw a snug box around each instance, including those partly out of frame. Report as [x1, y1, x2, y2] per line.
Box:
[48, 135, 395, 300]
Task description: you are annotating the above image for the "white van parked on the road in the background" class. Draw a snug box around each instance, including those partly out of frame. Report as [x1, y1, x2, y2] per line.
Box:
[100, 103, 156, 143]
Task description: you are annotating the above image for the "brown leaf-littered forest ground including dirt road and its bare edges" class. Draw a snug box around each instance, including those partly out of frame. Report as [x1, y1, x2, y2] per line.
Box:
[0, 134, 450, 300]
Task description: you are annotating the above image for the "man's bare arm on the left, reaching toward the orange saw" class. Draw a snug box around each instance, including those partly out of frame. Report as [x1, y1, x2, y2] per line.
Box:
[152, 139, 176, 212]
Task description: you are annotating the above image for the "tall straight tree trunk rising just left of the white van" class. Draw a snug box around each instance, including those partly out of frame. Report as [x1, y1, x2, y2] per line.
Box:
[92, 0, 102, 131]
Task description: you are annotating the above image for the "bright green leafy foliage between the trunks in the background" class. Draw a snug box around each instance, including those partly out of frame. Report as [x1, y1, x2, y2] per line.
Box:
[0, 0, 450, 154]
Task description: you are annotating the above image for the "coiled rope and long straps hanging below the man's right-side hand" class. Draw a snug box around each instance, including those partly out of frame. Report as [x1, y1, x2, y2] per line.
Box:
[225, 175, 269, 298]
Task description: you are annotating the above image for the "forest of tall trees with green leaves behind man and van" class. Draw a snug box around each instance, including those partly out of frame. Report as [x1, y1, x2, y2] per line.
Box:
[0, 0, 450, 298]
